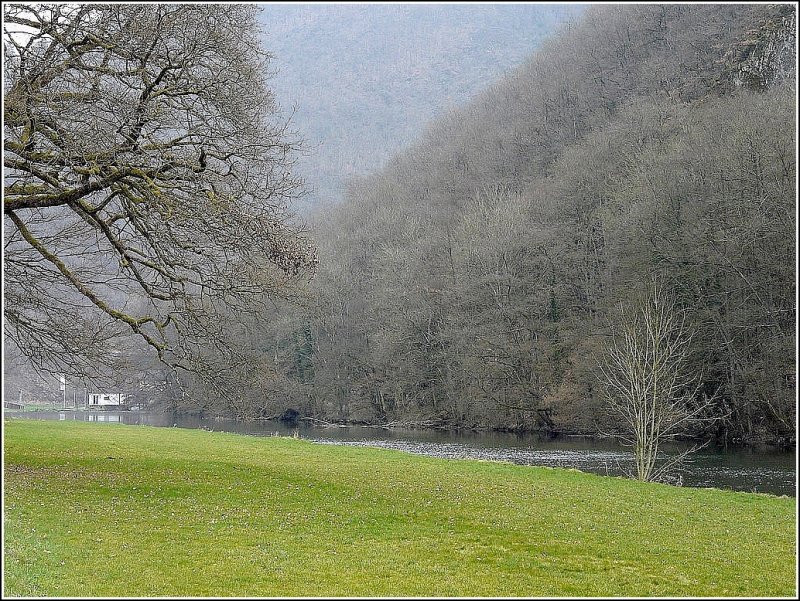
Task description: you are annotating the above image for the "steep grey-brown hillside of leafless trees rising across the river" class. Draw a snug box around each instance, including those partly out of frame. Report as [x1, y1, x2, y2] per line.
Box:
[250, 5, 796, 440]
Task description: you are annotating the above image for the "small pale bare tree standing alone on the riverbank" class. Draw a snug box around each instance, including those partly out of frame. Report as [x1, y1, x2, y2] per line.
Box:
[600, 280, 717, 481]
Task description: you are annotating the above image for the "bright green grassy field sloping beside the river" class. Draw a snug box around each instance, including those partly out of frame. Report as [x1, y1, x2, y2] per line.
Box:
[3, 420, 796, 597]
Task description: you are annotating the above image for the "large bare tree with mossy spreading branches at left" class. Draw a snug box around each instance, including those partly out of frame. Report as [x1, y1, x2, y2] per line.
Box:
[3, 3, 316, 384]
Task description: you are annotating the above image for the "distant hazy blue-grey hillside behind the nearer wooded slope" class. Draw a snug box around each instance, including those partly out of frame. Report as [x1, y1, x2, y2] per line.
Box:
[261, 3, 583, 203]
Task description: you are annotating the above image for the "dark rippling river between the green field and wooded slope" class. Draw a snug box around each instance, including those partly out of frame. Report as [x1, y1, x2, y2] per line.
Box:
[3, 410, 797, 497]
